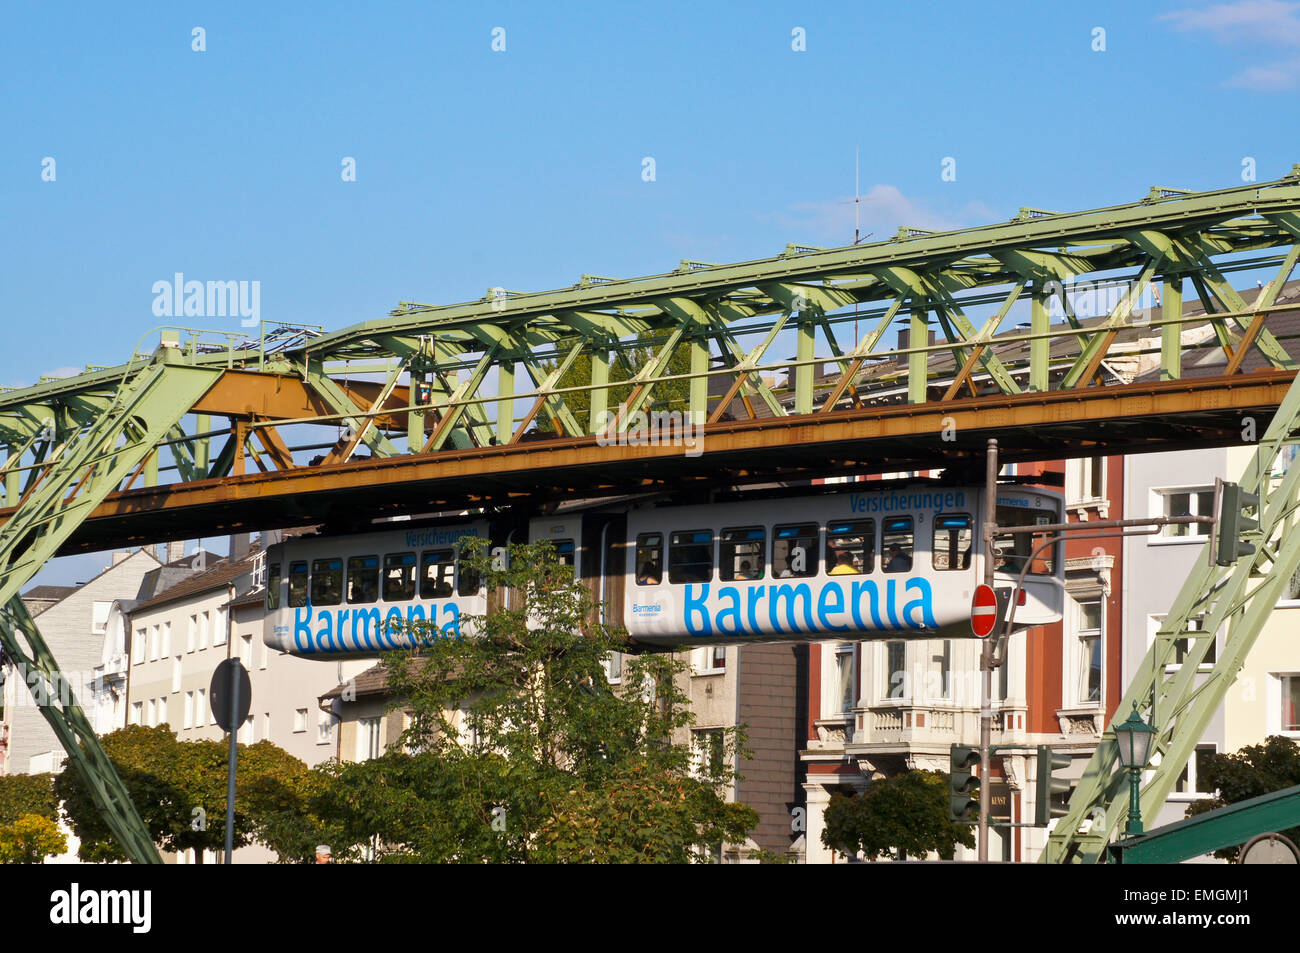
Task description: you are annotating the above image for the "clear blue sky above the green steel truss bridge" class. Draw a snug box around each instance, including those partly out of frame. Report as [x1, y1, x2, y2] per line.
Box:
[0, 0, 1300, 582]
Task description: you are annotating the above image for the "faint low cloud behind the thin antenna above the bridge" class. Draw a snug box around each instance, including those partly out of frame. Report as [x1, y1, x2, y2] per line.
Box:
[775, 185, 997, 246]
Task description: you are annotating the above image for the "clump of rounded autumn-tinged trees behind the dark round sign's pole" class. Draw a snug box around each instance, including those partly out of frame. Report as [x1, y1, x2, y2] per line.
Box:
[55, 724, 319, 862]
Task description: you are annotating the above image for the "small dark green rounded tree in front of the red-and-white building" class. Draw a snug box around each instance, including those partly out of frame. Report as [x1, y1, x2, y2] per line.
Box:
[822, 771, 975, 861]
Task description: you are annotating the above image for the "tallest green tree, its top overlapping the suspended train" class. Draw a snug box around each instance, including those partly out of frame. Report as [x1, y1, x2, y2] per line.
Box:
[312, 543, 758, 863]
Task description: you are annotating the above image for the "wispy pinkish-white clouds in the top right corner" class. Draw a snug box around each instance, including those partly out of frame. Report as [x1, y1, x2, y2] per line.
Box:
[1157, 0, 1300, 92]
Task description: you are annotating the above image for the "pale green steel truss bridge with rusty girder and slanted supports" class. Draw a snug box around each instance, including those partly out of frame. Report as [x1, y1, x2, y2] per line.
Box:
[0, 166, 1300, 862]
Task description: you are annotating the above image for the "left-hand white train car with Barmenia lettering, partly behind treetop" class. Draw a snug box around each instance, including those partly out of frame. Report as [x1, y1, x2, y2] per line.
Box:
[264, 520, 488, 658]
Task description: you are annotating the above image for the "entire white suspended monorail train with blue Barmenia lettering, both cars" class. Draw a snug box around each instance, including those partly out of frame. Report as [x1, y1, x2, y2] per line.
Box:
[264, 482, 1065, 658]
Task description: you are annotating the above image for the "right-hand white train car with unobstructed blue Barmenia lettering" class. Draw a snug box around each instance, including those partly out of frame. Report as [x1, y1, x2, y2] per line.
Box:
[623, 484, 1063, 646]
